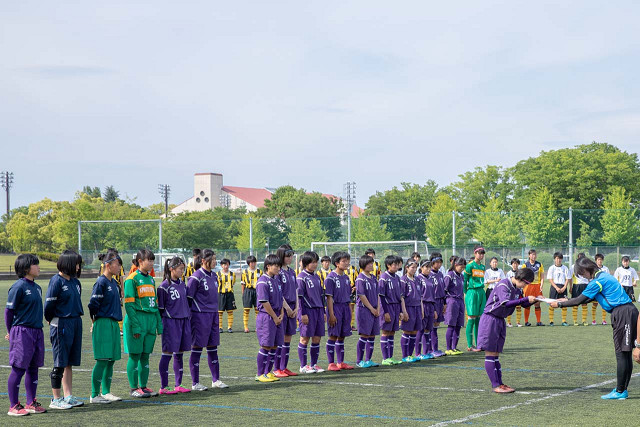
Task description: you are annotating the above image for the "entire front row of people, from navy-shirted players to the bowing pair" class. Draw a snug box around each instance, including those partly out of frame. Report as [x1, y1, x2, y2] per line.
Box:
[5, 245, 640, 415]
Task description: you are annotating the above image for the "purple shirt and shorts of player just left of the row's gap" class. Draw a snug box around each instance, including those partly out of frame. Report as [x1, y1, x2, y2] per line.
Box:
[187, 268, 220, 348]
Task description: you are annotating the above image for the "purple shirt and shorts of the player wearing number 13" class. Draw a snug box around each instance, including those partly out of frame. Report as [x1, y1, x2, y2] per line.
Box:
[297, 270, 325, 337]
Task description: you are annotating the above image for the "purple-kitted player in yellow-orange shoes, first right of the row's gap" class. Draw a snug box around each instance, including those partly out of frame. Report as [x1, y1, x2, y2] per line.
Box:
[256, 254, 284, 383]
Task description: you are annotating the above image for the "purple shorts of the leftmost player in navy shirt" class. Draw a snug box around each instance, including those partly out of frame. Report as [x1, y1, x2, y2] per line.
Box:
[9, 326, 44, 369]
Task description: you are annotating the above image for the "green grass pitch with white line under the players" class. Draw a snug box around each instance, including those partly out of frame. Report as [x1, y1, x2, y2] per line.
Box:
[0, 279, 640, 426]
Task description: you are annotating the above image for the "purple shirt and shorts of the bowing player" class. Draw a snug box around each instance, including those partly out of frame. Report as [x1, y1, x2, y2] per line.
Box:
[478, 279, 531, 353]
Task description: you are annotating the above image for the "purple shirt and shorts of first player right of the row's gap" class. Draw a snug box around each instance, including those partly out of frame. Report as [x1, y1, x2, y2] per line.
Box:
[256, 273, 286, 347]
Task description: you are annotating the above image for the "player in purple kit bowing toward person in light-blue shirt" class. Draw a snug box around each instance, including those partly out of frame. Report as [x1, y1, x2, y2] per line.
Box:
[478, 267, 536, 393]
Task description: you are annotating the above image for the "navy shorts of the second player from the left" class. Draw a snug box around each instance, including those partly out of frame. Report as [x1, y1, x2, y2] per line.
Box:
[49, 316, 82, 368]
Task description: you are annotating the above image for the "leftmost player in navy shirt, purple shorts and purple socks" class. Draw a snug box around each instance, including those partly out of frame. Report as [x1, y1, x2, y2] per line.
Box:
[4, 254, 47, 416]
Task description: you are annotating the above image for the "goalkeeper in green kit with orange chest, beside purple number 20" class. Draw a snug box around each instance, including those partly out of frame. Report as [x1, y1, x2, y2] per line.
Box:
[124, 249, 162, 397]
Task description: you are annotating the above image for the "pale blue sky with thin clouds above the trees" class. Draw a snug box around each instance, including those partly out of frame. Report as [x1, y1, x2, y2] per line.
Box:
[0, 0, 640, 211]
